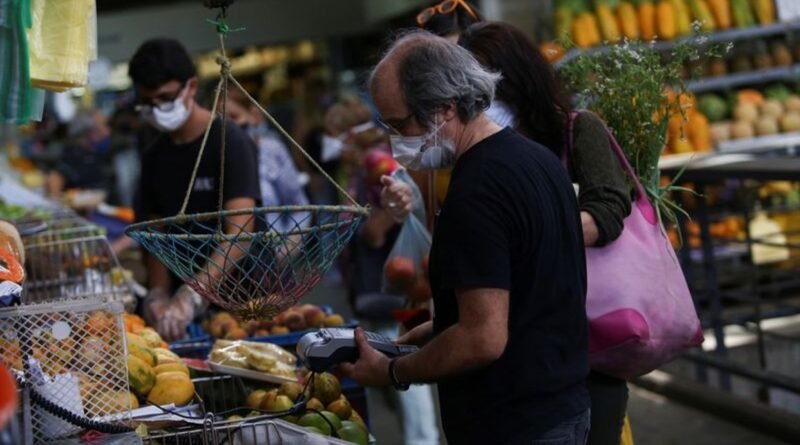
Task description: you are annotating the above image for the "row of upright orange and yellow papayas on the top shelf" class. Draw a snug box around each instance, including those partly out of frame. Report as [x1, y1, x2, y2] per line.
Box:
[554, 0, 775, 48]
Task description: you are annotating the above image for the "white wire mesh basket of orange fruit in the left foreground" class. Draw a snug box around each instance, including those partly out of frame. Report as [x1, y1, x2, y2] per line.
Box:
[0, 299, 131, 443]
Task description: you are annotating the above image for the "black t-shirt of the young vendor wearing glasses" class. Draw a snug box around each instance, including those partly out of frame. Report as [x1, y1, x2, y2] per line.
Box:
[136, 119, 261, 287]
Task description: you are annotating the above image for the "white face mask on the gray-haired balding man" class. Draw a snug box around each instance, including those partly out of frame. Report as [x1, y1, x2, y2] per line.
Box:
[389, 116, 456, 170]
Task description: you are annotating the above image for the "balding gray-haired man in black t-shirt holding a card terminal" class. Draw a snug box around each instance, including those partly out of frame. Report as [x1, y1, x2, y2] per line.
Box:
[343, 31, 589, 445]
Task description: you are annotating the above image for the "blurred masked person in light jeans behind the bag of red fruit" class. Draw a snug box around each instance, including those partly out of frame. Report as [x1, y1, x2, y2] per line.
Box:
[322, 96, 440, 445]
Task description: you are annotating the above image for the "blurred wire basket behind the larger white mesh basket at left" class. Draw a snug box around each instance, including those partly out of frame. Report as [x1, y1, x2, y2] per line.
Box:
[22, 234, 136, 310]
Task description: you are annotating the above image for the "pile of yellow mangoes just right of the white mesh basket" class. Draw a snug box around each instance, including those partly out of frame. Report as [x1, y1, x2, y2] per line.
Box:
[125, 314, 194, 409]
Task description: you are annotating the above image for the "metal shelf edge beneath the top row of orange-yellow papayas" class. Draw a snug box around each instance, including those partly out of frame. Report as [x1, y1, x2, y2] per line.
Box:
[554, 21, 800, 69]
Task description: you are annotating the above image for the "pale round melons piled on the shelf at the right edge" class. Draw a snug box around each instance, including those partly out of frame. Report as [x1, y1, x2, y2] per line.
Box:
[698, 85, 800, 143]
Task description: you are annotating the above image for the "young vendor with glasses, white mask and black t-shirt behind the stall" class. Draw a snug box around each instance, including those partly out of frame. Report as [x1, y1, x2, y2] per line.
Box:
[128, 39, 261, 341]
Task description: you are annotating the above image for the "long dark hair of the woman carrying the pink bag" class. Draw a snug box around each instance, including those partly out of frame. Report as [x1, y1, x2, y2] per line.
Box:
[458, 22, 569, 156]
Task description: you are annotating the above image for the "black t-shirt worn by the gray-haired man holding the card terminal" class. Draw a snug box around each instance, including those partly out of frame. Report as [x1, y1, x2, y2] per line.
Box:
[430, 128, 589, 445]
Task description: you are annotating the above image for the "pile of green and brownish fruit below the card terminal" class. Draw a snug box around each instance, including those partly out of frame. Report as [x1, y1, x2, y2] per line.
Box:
[229, 373, 369, 445]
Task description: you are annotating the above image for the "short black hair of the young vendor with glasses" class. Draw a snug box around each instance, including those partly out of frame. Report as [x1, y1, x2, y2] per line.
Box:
[128, 39, 197, 89]
